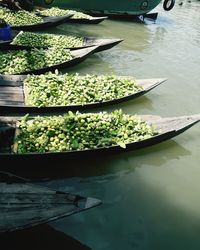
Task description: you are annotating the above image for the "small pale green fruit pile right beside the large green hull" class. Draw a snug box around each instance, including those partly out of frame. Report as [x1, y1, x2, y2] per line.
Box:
[39, 7, 92, 19]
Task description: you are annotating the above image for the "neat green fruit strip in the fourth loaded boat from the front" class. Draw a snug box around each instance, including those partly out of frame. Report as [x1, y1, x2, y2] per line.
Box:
[12, 32, 84, 48]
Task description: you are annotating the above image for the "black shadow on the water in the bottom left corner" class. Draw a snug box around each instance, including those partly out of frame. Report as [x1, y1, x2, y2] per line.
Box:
[0, 225, 91, 250]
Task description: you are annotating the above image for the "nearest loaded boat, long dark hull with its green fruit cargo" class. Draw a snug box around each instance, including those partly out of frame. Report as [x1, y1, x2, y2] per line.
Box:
[0, 111, 200, 161]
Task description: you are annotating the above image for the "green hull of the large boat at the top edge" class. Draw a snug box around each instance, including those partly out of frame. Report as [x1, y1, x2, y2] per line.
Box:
[35, 0, 161, 15]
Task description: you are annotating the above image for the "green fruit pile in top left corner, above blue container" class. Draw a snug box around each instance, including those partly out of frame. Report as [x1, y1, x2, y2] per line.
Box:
[0, 6, 43, 26]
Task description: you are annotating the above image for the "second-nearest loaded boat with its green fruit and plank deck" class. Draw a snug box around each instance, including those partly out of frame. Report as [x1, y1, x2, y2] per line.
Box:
[0, 73, 166, 113]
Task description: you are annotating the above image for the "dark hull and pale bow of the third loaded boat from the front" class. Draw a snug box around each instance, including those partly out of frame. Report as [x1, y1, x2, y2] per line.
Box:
[0, 46, 98, 75]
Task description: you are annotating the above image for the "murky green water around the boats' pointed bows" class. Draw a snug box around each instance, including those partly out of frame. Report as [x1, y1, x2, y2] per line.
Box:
[5, 0, 200, 250]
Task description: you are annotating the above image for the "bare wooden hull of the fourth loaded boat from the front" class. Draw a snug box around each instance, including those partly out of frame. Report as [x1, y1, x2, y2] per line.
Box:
[0, 31, 123, 53]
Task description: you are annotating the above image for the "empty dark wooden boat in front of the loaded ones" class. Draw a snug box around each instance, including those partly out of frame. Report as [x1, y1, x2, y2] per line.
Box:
[0, 172, 101, 233]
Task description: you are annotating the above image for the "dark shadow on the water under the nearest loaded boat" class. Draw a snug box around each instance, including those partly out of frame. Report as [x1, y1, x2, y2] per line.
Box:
[0, 140, 191, 182]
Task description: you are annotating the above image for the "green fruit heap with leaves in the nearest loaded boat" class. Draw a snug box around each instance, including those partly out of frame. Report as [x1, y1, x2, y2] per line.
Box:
[15, 110, 157, 154]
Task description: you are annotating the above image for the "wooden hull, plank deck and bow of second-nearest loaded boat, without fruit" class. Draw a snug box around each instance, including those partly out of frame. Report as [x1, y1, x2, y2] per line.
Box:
[0, 75, 166, 113]
